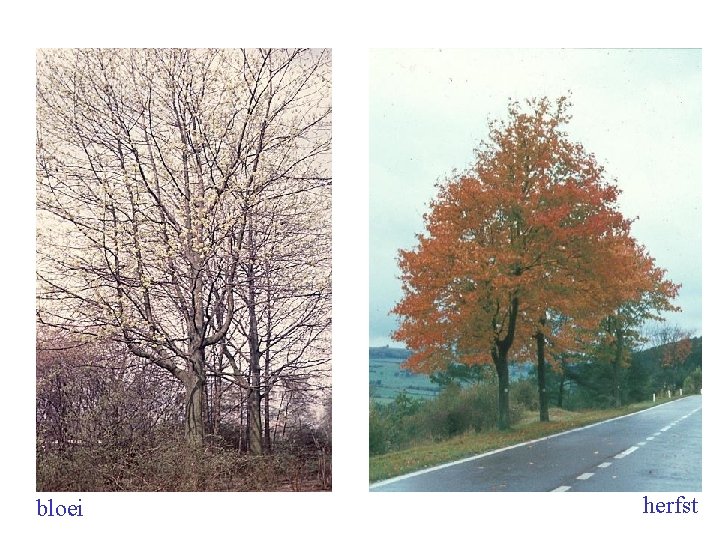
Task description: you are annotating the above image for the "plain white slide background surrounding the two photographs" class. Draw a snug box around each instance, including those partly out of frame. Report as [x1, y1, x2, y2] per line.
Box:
[0, 0, 720, 539]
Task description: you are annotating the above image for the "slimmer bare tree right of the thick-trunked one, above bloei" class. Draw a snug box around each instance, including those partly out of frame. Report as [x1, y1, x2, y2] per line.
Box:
[211, 184, 331, 453]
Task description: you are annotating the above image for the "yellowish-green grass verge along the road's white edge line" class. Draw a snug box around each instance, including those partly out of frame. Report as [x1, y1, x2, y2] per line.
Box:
[370, 399, 670, 483]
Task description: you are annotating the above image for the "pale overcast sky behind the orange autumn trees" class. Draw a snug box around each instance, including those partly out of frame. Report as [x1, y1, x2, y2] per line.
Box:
[369, 49, 702, 346]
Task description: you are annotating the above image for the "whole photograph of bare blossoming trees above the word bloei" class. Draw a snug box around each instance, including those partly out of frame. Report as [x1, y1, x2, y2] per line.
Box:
[36, 49, 332, 492]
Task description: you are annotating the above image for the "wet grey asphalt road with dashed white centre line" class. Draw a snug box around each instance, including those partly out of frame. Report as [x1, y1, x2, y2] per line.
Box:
[370, 396, 702, 492]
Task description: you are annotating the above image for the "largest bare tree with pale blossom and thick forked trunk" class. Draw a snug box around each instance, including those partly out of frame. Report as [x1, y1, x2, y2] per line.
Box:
[37, 49, 330, 445]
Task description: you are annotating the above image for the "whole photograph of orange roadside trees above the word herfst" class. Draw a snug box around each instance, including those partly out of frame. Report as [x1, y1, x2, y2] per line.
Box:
[368, 49, 702, 494]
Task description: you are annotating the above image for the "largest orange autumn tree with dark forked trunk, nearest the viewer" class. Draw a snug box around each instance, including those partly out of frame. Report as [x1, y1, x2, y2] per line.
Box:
[393, 98, 656, 429]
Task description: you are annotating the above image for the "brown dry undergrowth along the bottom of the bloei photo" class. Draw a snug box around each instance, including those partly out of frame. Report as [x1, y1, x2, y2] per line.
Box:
[36, 440, 332, 492]
